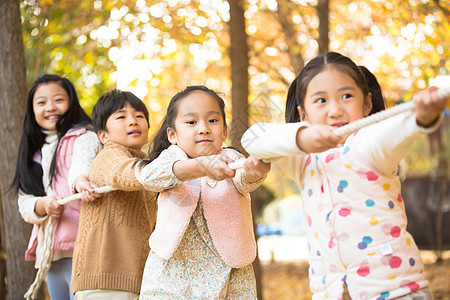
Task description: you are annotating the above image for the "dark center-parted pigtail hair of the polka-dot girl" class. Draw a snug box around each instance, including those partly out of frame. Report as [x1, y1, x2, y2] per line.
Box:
[285, 52, 386, 123]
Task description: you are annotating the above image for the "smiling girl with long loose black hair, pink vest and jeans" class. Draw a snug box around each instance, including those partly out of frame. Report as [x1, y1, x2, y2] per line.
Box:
[12, 74, 101, 299]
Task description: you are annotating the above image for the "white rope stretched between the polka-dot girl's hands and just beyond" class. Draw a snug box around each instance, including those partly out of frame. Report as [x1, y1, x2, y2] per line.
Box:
[333, 88, 450, 136]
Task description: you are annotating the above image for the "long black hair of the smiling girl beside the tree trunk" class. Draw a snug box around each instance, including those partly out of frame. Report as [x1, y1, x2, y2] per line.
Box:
[10, 74, 92, 196]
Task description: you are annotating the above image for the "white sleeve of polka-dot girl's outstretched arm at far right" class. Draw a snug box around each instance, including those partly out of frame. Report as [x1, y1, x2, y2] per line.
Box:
[353, 111, 443, 176]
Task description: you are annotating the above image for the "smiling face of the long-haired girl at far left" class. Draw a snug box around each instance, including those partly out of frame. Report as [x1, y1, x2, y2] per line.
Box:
[33, 82, 69, 130]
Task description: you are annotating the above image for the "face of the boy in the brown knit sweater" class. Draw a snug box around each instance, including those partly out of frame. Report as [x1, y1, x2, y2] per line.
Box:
[98, 103, 148, 149]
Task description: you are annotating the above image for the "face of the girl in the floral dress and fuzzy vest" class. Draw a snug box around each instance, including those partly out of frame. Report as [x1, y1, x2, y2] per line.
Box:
[167, 91, 227, 158]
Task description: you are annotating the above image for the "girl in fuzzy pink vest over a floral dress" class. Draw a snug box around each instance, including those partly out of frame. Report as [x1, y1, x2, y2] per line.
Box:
[136, 86, 270, 299]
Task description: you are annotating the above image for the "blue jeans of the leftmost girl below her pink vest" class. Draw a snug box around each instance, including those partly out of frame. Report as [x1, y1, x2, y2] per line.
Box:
[47, 258, 74, 300]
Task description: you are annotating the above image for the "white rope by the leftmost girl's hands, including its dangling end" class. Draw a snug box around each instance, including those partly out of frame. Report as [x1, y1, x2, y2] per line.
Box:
[24, 185, 117, 300]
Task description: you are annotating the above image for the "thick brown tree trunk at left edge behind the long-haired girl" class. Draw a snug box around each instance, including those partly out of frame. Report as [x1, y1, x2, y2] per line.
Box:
[0, 0, 42, 300]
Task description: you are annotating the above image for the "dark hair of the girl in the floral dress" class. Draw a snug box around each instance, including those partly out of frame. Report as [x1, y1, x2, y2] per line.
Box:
[148, 85, 227, 162]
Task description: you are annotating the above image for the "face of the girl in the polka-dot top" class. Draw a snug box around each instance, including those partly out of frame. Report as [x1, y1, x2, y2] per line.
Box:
[299, 67, 372, 127]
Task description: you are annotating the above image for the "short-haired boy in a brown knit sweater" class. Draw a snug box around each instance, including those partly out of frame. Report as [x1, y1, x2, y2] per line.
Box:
[72, 90, 156, 300]
